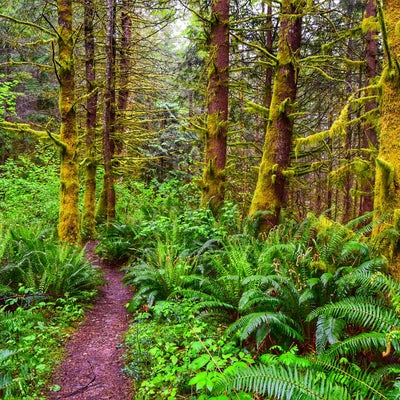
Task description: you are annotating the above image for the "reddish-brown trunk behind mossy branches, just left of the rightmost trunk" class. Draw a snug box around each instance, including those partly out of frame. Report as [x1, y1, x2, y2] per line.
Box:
[360, 0, 378, 214]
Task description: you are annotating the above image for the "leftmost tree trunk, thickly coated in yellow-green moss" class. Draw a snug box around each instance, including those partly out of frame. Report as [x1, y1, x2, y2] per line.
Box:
[57, 0, 80, 244]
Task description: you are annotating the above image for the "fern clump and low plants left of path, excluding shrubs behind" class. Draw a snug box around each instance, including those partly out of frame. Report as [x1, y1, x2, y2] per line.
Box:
[0, 226, 103, 399]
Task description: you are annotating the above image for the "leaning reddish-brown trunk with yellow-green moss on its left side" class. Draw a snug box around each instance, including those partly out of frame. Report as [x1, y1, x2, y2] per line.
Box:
[249, 0, 303, 231]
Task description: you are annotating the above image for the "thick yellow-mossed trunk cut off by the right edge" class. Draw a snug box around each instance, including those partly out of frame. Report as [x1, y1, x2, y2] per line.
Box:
[373, 0, 400, 260]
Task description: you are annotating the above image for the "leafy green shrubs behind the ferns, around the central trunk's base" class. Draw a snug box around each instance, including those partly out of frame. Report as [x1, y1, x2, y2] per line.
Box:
[98, 180, 240, 264]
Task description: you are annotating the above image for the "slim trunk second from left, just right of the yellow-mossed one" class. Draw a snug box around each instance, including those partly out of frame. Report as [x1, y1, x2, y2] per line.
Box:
[82, 0, 97, 239]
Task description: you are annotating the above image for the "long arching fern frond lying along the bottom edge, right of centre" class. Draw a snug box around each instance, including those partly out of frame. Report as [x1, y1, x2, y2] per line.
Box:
[214, 357, 395, 400]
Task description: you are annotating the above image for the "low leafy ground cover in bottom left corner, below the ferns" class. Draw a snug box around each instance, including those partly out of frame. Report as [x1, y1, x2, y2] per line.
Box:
[0, 287, 84, 400]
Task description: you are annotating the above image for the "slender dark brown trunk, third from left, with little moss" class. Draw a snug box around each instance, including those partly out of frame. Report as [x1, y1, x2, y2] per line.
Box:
[97, 0, 116, 223]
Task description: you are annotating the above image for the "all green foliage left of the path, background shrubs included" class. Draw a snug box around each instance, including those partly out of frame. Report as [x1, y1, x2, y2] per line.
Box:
[0, 157, 102, 399]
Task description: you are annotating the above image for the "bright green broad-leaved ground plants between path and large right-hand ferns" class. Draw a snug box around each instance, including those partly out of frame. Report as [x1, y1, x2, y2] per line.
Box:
[125, 300, 253, 400]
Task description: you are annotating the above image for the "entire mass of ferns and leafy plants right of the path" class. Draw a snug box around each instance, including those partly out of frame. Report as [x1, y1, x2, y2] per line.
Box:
[98, 181, 400, 400]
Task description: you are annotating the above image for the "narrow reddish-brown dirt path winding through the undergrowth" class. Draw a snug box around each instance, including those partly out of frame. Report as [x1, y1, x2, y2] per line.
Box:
[46, 243, 132, 400]
